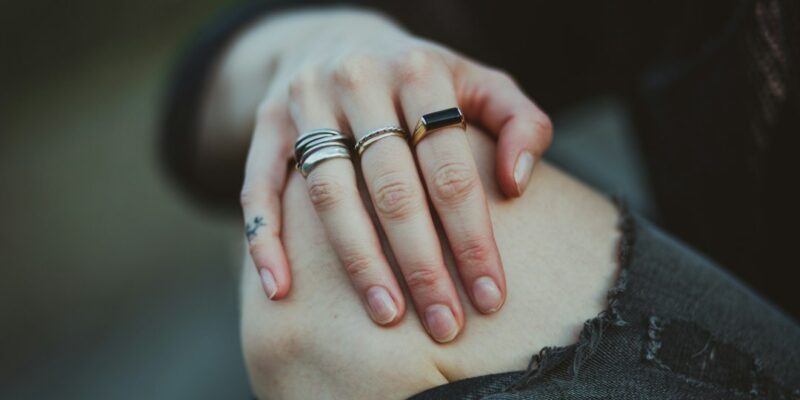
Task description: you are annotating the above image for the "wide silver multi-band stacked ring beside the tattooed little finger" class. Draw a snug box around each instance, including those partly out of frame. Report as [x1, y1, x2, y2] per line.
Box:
[294, 129, 352, 177]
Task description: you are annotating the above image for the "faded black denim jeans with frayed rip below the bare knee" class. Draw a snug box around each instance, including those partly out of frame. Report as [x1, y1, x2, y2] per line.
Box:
[412, 214, 800, 400]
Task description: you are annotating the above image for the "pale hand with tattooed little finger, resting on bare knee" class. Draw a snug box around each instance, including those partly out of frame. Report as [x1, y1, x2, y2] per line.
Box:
[241, 12, 552, 342]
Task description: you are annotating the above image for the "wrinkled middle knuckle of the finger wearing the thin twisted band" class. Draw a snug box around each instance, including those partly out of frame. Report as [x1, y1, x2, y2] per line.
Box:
[374, 173, 420, 220]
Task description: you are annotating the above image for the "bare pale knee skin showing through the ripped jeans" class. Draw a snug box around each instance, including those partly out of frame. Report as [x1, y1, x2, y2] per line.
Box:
[241, 130, 619, 399]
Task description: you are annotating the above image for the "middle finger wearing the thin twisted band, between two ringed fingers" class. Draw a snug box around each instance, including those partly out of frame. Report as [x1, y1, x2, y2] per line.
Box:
[338, 59, 464, 342]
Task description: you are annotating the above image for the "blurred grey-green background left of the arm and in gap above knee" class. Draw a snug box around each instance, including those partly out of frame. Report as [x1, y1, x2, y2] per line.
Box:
[0, 0, 653, 399]
